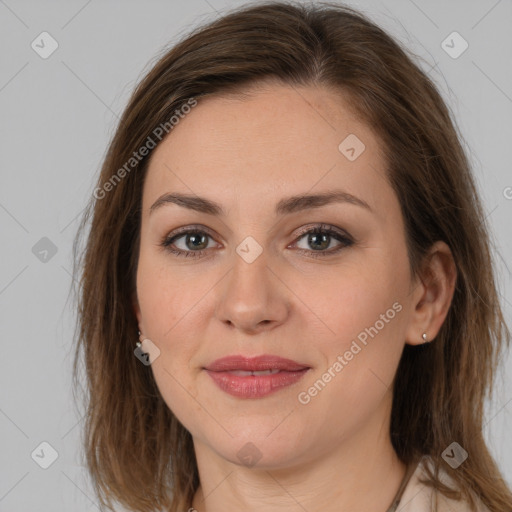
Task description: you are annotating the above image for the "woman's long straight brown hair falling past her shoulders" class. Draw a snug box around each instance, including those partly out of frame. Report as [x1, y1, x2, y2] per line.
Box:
[74, 2, 512, 512]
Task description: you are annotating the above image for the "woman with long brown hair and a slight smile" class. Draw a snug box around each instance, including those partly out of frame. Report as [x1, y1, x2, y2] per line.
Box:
[75, 3, 512, 512]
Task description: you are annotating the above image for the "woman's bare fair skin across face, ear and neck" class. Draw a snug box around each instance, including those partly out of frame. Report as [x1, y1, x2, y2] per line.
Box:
[133, 83, 455, 512]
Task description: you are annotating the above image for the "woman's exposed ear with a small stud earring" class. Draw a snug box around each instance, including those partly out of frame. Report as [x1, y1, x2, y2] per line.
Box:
[406, 241, 457, 345]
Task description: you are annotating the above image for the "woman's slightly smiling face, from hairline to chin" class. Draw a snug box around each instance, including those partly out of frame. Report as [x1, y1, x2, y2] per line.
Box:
[134, 85, 421, 468]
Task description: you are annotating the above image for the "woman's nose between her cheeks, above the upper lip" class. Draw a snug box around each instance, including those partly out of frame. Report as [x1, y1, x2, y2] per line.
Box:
[216, 251, 291, 334]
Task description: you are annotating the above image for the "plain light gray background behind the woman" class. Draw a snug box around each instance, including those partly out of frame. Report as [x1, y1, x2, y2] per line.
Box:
[0, 0, 512, 512]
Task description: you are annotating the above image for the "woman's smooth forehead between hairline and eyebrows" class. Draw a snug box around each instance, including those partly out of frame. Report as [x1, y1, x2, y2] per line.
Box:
[143, 85, 385, 214]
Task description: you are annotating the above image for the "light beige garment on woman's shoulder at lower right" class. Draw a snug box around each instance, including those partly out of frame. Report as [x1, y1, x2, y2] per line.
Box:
[396, 456, 489, 512]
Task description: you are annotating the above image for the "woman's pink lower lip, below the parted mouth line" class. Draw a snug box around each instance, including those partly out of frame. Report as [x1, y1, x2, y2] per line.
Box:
[205, 368, 309, 398]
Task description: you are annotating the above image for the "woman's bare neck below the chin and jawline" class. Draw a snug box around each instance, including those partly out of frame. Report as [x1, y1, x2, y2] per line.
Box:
[192, 400, 406, 512]
